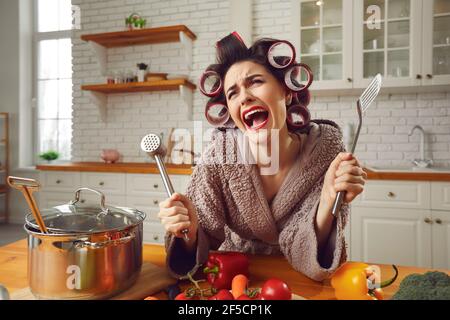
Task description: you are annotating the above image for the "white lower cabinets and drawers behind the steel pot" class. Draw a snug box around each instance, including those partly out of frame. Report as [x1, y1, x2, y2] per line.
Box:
[36, 171, 190, 244]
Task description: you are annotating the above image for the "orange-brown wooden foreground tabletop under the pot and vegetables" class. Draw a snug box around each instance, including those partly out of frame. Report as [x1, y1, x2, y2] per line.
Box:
[0, 240, 450, 300]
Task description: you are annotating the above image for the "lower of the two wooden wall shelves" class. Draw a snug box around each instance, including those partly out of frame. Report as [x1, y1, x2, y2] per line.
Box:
[81, 79, 196, 93]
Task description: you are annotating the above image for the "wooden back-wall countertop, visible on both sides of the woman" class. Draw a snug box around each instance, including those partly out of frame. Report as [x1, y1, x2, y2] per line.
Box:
[36, 162, 450, 182]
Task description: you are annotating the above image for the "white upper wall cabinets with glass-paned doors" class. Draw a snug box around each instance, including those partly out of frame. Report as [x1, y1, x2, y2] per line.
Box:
[292, 0, 450, 90]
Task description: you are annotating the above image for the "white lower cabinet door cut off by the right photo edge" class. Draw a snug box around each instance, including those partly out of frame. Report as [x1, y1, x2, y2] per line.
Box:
[432, 211, 450, 269]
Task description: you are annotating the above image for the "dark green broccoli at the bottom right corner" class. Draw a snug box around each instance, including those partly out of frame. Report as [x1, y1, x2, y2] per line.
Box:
[392, 271, 450, 300]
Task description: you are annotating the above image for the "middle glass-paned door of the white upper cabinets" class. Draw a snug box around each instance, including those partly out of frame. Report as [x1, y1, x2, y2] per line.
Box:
[353, 0, 428, 88]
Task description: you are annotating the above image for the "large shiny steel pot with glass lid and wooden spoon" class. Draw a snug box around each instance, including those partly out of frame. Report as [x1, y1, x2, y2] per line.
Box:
[24, 188, 145, 299]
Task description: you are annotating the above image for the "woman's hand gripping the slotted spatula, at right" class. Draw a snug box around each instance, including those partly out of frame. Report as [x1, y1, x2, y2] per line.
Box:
[321, 152, 367, 208]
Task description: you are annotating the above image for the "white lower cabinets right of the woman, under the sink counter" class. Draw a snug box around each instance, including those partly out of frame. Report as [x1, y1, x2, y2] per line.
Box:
[350, 180, 450, 268]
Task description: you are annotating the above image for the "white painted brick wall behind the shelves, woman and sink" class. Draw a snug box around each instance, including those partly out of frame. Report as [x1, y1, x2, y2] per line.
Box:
[72, 0, 450, 167]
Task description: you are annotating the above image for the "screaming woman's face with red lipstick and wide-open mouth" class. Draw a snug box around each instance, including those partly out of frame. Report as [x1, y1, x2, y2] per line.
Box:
[224, 61, 290, 143]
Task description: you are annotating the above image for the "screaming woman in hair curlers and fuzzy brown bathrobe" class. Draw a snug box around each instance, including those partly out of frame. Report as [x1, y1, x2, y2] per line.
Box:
[158, 33, 367, 281]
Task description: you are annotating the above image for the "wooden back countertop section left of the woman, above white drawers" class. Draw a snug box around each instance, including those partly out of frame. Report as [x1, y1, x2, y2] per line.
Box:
[36, 162, 192, 175]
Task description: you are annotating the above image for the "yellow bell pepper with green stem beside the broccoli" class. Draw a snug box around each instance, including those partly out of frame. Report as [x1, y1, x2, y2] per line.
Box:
[331, 262, 398, 300]
